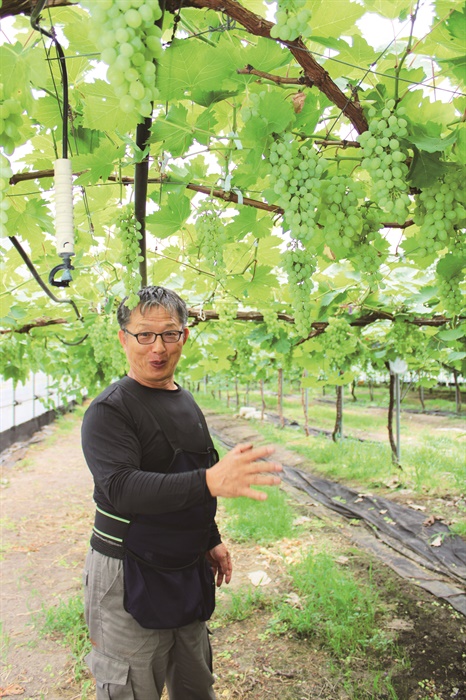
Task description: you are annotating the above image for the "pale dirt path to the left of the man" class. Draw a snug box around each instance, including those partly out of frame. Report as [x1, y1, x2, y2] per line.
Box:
[0, 418, 93, 700]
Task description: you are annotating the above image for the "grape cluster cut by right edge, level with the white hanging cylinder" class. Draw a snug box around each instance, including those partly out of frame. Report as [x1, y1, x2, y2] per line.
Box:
[414, 168, 466, 257]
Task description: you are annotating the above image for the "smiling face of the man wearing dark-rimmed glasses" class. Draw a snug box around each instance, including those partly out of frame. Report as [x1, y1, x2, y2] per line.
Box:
[118, 306, 189, 389]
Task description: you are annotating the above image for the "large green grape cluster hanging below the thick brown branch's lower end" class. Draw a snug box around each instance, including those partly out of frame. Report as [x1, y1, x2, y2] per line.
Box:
[358, 100, 410, 223]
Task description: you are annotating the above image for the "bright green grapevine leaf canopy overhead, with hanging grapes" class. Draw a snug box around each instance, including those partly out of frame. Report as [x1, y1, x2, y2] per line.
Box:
[0, 0, 466, 389]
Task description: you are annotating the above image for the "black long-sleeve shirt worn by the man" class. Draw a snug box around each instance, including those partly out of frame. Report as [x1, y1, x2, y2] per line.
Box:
[82, 377, 221, 548]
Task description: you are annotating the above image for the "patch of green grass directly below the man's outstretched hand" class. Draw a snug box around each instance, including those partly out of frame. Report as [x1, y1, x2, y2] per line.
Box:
[224, 486, 296, 544]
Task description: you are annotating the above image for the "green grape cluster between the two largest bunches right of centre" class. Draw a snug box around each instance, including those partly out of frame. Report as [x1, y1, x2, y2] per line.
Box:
[319, 175, 364, 259]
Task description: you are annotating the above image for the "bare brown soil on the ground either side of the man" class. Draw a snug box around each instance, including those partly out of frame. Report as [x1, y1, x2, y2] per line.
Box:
[0, 408, 466, 700]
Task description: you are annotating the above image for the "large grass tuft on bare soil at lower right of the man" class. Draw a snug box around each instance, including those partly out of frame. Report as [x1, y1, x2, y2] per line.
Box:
[275, 553, 390, 661]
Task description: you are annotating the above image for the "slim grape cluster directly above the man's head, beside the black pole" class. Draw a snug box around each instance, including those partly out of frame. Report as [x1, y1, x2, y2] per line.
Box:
[118, 207, 143, 309]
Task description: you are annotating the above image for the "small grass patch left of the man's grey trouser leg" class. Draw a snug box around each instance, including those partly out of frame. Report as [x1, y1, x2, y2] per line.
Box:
[36, 594, 91, 682]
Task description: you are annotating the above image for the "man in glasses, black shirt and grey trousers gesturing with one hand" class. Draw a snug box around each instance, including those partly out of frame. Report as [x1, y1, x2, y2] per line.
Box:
[82, 287, 281, 700]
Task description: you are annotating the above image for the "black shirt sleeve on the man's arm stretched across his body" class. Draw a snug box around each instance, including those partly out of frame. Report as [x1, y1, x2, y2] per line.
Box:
[82, 402, 210, 515]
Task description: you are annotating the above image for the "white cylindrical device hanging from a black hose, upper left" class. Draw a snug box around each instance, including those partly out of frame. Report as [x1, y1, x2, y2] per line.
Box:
[49, 158, 74, 287]
